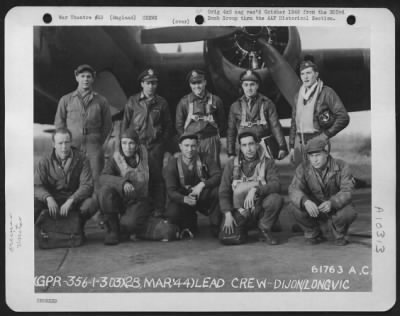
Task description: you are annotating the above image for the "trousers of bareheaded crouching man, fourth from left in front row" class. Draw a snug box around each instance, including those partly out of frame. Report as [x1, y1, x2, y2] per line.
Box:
[220, 193, 283, 242]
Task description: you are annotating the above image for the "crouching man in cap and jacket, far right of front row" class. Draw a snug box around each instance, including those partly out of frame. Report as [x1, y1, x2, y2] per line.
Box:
[289, 138, 357, 246]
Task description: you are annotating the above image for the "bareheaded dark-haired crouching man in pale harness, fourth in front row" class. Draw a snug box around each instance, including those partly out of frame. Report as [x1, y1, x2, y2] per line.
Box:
[219, 132, 283, 245]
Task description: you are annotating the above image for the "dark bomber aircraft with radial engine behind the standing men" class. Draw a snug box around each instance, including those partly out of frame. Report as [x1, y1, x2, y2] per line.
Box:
[34, 26, 370, 124]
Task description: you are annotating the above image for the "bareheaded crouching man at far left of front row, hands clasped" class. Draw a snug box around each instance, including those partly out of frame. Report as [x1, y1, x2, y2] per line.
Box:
[34, 127, 94, 241]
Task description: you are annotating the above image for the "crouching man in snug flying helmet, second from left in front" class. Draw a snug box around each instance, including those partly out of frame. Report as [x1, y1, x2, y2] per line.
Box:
[99, 127, 150, 245]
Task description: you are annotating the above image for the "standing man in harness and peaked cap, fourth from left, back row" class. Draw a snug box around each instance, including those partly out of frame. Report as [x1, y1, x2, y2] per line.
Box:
[227, 69, 288, 159]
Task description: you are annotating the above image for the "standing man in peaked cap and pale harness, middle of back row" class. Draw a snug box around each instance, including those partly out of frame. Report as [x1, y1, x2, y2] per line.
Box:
[175, 69, 226, 166]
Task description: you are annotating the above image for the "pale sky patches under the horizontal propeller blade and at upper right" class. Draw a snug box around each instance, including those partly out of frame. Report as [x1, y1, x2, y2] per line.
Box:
[152, 26, 370, 53]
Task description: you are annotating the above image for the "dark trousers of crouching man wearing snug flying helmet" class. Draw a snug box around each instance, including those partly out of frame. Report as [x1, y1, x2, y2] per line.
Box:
[99, 184, 150, 234]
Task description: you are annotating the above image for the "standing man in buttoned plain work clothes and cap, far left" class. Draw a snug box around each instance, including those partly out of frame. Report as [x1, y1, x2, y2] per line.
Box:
[54, 65, 112, 187]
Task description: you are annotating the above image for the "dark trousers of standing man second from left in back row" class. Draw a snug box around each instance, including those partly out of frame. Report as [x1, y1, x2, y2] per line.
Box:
[148, 144, 166, 213]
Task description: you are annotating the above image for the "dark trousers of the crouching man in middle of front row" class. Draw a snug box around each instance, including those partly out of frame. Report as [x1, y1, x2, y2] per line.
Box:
[165, 187, 221, 236]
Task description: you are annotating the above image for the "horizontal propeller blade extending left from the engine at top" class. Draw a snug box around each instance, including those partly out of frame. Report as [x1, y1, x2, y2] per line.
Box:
[141, 26, 239, 44]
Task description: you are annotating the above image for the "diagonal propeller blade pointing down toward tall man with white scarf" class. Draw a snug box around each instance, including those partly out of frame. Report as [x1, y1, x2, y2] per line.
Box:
[258, 38, 301, 107]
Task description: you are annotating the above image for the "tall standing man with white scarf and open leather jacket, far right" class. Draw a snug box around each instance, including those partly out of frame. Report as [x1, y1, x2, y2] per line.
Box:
[289, 61, 350, 166]
